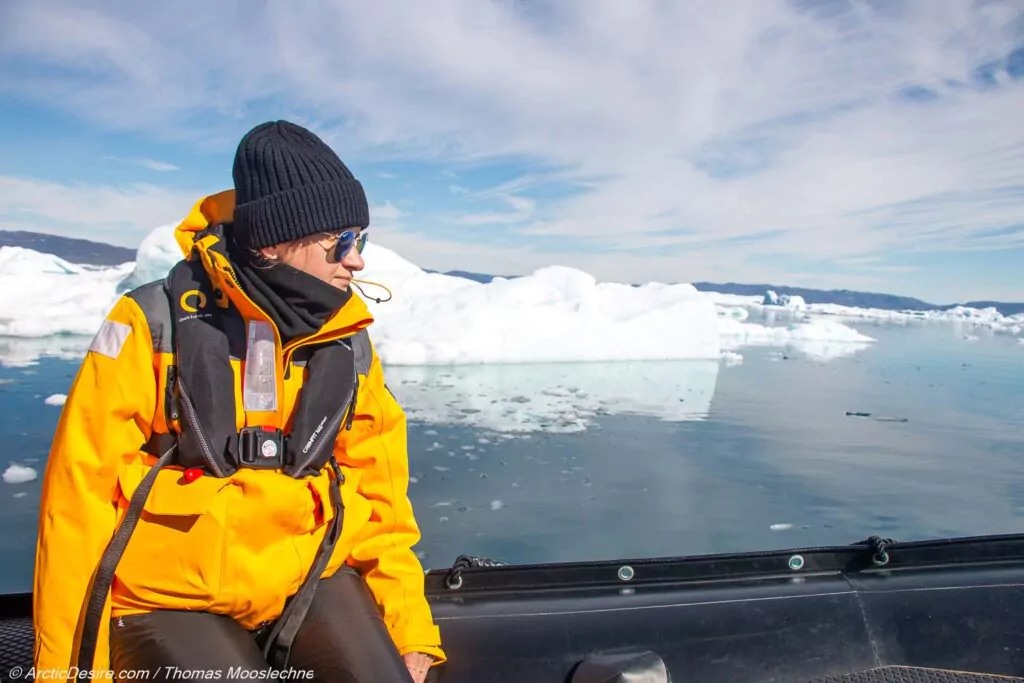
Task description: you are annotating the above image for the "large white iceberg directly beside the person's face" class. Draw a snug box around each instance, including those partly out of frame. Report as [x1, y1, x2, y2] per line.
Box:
[361, 254, 721, 366]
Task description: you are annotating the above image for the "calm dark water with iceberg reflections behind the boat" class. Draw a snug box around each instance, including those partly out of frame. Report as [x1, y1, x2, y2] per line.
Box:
[0, 323, 1024, 591]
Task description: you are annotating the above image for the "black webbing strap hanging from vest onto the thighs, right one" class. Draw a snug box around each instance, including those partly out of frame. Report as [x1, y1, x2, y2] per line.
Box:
[263, 457, 344, 670]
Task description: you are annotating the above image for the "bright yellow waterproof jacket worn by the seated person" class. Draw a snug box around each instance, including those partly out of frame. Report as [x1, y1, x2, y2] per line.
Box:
[34, 190, 444, 680]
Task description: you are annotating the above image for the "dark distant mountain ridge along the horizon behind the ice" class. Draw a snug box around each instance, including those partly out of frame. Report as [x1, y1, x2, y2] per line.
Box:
[0, 230, 1024, 315]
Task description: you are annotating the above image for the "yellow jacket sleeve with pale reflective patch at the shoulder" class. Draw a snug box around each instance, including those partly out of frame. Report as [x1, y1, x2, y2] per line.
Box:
[33, 297, 156, 681]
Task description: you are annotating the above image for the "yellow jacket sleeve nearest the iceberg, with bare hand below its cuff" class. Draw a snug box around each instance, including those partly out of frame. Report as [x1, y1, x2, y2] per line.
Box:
[344, 339, 445, 664]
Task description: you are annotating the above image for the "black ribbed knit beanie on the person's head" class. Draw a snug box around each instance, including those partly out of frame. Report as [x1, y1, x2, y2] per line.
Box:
[231, 121, 370, 249]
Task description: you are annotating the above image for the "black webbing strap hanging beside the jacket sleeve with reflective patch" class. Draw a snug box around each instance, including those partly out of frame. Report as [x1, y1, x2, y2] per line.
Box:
[78, 444, 177, 673]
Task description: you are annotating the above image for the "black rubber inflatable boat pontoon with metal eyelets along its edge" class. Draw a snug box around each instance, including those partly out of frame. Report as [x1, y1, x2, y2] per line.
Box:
[0, 535, 1024, 683]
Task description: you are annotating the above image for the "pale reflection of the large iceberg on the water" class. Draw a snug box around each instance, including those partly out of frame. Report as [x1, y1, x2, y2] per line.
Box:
[385, 360, 719, 433]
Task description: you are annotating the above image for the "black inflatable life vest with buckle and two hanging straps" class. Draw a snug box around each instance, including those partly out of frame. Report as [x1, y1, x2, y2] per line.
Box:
[78, 237, 358, 671]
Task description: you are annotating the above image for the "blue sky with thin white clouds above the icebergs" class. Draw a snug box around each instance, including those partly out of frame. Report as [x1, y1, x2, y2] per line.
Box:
[0, 0, 1024, 302]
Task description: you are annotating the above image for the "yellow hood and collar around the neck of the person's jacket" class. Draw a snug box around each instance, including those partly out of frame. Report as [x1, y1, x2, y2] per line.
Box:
[174, 189, 374, 341]
